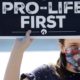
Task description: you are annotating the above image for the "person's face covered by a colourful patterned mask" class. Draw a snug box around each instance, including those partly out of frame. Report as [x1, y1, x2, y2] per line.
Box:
[61, 39, 80, 73]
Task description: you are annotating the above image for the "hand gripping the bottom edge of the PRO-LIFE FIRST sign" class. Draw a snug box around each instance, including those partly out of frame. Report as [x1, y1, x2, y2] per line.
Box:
[13, 30, 32, 52]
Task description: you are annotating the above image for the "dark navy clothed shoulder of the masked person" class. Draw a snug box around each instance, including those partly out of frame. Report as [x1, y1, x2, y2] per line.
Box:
[21, 64, 59, 80]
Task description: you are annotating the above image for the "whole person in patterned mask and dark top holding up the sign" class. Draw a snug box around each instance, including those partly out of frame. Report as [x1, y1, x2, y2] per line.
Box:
[4, 30, 80, 80]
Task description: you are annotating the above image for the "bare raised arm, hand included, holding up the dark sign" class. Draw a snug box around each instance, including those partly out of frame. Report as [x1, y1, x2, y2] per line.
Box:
[4, 31, 32, 80]
